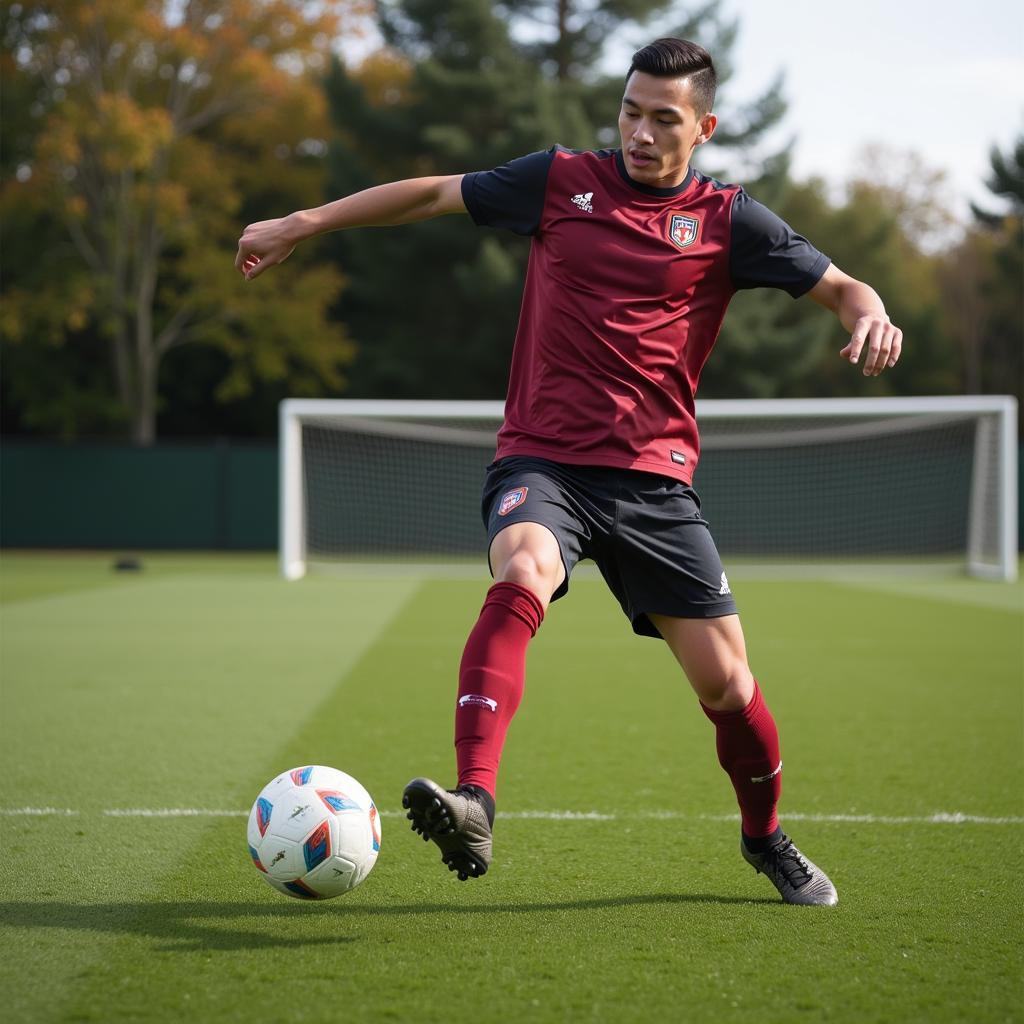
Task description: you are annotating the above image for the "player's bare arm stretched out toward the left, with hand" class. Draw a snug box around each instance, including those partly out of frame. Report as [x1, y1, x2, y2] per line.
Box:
[234, 174, 466, 281]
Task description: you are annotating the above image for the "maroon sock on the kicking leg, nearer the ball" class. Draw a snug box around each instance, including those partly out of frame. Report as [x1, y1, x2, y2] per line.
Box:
[455, 583, 544, 797]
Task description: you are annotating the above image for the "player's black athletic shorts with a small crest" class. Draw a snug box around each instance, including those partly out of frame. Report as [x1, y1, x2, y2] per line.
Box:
[482, 456, 736, 637]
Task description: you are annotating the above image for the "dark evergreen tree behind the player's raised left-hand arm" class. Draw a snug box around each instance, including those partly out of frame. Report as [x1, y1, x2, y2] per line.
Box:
[327, 0, 569, 398]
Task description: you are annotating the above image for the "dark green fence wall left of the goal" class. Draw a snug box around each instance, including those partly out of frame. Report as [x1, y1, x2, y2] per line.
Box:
[0, 440, 278, 550]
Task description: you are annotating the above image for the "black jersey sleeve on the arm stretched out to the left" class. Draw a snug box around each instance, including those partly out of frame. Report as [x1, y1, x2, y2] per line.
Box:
[462, 148, 555, 234]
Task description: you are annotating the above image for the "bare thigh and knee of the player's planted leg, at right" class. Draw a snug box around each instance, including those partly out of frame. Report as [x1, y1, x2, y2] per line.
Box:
[648, 613, 754, 711]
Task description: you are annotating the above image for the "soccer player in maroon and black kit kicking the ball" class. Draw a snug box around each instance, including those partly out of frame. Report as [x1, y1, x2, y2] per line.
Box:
[236, 39, 902, 905]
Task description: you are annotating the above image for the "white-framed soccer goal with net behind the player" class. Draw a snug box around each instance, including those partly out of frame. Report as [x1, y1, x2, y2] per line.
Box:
[281, 395, 1018, 580]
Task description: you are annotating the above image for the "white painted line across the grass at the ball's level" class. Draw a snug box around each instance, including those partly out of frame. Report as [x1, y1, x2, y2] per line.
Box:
[0, 807, 1024, 825]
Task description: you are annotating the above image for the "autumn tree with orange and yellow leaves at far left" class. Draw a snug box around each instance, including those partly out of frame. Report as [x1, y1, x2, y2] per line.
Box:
[0, 0, 368, 443]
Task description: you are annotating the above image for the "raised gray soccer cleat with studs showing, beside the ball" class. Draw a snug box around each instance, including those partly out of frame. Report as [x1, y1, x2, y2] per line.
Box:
[401, 778, 490, 882]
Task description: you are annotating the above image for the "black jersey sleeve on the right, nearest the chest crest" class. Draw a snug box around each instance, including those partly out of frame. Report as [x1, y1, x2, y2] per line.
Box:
[729, 189, 831, 299]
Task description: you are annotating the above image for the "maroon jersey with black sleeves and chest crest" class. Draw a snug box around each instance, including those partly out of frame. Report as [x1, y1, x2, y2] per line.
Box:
[462, 146, 828, 483]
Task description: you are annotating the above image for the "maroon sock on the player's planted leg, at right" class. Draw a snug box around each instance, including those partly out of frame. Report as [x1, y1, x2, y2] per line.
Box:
[700, 681, 782, 839]
